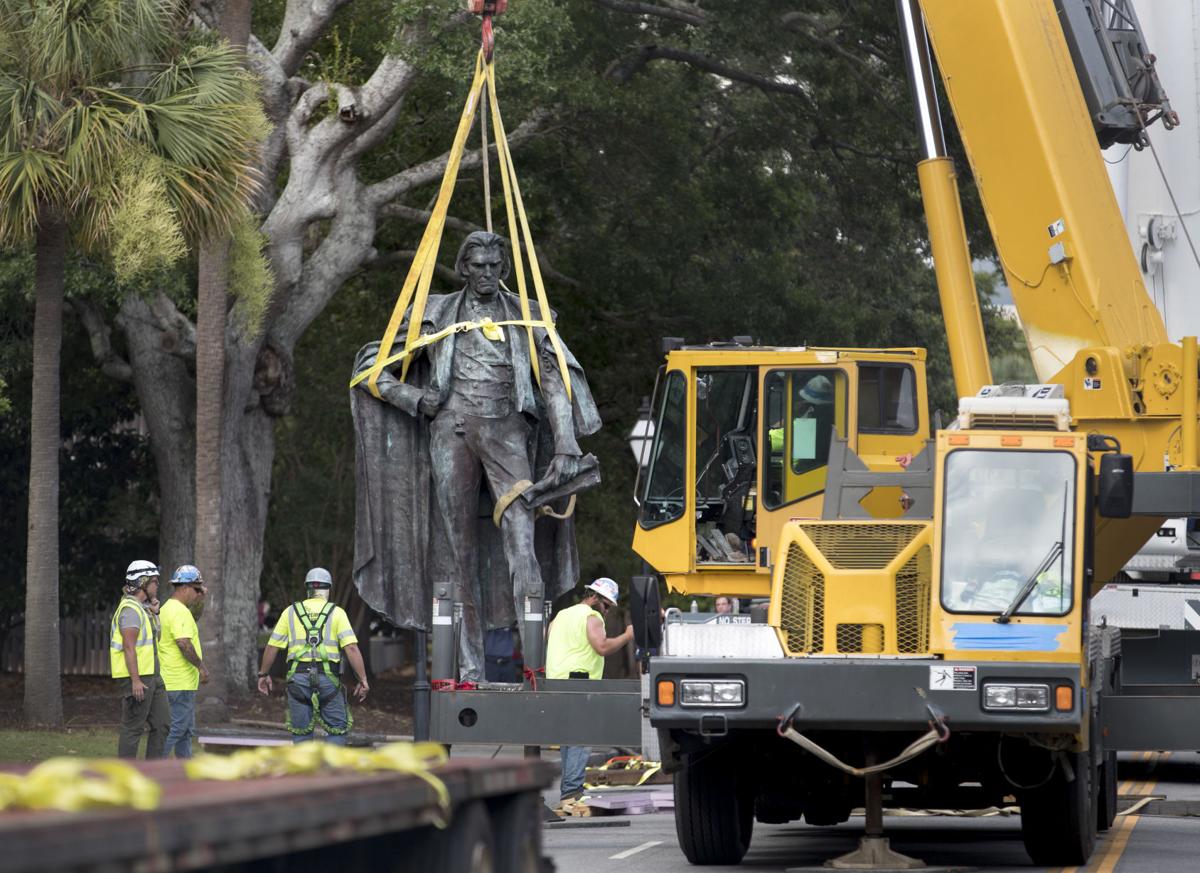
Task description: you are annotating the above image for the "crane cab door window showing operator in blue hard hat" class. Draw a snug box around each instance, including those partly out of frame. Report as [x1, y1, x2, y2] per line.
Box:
[763, 369, 850, 510]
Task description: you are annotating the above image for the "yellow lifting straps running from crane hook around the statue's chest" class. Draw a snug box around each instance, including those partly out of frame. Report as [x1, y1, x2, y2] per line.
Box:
[350, 50, 571, 398]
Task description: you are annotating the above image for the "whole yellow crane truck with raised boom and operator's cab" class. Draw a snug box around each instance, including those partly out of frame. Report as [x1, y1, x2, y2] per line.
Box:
[634, 0, 1200, 868]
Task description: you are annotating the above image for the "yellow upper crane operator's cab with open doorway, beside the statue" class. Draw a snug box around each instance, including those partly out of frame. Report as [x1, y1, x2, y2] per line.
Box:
[634, 344, 930, 597]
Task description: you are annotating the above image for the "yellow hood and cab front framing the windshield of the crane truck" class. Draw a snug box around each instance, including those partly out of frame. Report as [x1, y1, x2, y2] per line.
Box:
[768, 431, 1090, 666]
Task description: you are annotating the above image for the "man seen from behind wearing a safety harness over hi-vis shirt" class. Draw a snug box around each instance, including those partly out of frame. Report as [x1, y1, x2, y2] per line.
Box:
[258, 567, 370, 746]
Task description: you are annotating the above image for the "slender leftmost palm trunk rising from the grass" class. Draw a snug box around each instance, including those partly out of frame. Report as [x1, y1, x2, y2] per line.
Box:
[24, 210, 67, 726]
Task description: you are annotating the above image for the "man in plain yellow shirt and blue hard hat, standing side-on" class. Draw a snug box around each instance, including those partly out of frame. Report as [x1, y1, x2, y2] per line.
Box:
[158, 564, 209, 758]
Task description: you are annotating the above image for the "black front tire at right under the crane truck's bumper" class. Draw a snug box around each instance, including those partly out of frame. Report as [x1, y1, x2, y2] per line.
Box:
[1019, 752, 1096, 867]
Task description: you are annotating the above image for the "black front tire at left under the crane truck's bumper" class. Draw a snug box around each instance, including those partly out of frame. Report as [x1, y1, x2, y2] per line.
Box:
[674, 749, 754, 865]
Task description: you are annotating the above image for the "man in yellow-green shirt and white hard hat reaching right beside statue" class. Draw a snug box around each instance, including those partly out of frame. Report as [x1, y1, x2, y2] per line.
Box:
[546, 577, 634, 802]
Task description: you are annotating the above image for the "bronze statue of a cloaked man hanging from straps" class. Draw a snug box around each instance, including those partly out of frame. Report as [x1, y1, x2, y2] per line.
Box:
[350, 231, 600, 681]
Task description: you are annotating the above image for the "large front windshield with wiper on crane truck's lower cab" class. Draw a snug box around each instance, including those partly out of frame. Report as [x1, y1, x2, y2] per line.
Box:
[942, 450, 1075, 615]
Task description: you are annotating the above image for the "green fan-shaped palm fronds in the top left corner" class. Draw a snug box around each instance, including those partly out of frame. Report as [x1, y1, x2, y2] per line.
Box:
[0, 0, 268, 250]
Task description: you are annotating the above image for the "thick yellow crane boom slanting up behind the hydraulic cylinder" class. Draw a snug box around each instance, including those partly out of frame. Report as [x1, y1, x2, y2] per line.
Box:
[922, 0, 1166, 381]
